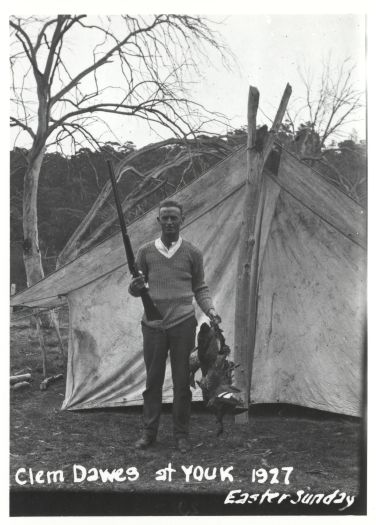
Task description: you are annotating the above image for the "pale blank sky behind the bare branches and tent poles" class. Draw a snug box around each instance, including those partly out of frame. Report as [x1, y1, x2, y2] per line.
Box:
[11, 13, 366, 147]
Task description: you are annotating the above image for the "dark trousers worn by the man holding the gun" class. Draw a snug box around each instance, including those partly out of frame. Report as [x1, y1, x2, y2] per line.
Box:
[142, 317, 197, 439]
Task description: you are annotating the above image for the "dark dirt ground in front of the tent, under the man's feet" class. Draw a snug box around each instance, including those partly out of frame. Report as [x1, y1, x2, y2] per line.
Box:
[10, 312, 364, 512]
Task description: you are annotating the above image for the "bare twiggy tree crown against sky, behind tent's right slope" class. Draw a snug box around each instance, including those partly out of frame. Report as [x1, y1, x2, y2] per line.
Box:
[287, 56, 364, 150]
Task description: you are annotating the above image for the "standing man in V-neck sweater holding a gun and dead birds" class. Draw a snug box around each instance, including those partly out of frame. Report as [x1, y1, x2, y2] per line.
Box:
[129, 199, 221, 452]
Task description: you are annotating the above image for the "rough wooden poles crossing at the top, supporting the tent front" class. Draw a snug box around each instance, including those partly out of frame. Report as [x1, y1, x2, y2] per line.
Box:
[234, 84, 291, 423]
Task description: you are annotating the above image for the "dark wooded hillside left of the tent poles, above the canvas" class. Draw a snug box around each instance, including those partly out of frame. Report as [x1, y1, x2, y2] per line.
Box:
[10, 131, 246, 288]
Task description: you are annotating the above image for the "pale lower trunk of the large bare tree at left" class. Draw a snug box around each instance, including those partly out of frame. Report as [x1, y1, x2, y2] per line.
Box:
[22, 148, 45, 287]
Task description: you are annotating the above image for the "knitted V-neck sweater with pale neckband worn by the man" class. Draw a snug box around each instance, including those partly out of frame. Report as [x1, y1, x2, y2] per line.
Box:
[129, 239, 213, 329]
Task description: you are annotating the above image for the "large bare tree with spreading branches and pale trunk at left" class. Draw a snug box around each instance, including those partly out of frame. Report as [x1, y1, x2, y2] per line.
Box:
[10, 15, 230, 286]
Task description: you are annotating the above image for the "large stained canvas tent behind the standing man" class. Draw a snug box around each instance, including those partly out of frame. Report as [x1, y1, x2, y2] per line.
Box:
[11, 148, 366, 416]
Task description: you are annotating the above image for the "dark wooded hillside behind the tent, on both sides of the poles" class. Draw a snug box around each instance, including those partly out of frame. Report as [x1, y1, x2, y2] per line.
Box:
[10, 127, 367, 288]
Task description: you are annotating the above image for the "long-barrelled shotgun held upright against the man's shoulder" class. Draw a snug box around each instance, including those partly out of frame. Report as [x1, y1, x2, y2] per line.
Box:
[107, 160, 163, 321]
